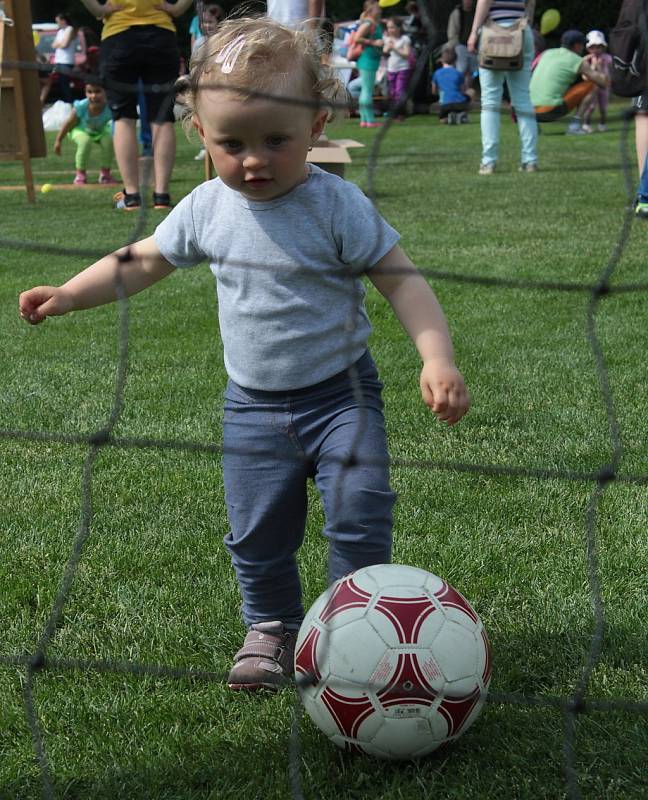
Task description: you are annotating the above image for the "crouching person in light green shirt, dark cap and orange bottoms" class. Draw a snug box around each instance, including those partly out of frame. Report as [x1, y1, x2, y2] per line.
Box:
[529, 31, 610, 134]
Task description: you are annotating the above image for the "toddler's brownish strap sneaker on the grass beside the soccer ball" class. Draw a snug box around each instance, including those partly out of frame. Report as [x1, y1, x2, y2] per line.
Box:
[227, 622, 297, 692]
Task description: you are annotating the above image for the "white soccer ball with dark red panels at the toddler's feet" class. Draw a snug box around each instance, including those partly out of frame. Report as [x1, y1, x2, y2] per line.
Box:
[295, 564, 491, 759]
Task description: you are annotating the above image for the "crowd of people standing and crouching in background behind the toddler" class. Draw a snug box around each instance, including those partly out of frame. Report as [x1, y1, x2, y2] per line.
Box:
[38, 0, 648, 217]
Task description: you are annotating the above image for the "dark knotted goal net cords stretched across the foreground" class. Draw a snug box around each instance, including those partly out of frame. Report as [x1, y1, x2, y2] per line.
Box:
[0, 3, 648, 800]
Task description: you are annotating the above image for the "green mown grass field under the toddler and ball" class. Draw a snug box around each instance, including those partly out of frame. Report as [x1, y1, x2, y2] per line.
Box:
[0, 108, 648, 800]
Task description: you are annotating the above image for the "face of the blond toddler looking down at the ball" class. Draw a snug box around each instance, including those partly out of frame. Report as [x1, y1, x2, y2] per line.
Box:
[194, 89, 326, 200]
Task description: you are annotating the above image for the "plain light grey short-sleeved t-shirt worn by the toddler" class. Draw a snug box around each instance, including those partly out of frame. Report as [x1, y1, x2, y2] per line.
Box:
[154, 165, 400, 391]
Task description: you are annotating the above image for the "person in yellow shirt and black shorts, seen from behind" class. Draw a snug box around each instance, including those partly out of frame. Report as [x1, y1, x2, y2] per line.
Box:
[81, 0, 193, 211]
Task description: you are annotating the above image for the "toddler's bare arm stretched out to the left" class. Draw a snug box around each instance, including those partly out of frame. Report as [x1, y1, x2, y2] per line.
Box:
[19, 236, 175, 325]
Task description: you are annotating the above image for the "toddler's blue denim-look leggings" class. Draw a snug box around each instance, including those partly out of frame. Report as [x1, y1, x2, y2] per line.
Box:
[223, 352, 396, 629]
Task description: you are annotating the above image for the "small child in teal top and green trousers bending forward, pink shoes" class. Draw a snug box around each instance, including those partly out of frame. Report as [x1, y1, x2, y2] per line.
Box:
[54, 83, 117, 186]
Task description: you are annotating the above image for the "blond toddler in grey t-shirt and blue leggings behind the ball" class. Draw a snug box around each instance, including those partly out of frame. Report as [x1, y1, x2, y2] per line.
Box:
[19, 17, 469, 690]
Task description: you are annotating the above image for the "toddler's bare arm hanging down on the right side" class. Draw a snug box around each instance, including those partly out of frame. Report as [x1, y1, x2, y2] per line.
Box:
[367, 245, 470, 425]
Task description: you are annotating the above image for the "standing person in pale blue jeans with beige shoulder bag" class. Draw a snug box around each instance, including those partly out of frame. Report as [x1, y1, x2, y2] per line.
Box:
[467, 0, 538, 175]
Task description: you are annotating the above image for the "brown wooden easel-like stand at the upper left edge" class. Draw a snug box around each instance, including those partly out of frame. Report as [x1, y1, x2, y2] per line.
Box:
[0, 0, 47, 203]
